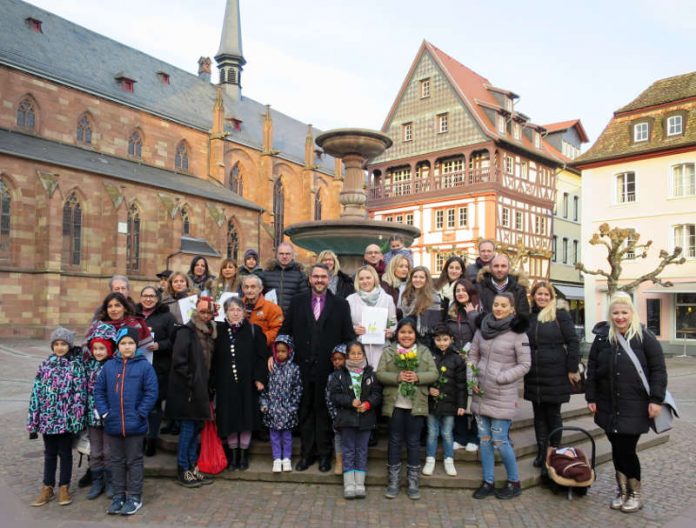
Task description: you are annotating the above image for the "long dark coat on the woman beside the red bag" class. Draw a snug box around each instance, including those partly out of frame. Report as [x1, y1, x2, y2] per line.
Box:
[165, 319, 215, 421]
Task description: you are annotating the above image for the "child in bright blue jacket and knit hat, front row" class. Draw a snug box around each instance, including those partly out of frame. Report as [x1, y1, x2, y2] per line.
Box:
[94, 327, 158, 515]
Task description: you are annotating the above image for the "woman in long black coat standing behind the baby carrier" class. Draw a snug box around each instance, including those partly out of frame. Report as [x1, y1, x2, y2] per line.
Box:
[524, 281, 580, 467]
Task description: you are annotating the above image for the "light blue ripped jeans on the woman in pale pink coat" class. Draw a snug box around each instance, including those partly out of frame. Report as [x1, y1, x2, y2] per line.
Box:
[476, 415, 520, 483]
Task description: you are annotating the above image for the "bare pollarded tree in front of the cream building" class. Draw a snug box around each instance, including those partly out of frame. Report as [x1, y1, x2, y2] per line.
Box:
[575, 223, 686, 297]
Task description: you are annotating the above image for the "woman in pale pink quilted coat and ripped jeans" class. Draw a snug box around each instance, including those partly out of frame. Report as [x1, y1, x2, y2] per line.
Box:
[469, 292, 532, 499]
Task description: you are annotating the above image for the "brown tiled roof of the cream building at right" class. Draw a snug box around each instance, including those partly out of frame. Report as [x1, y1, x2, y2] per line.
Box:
[573, 72, 696, 167]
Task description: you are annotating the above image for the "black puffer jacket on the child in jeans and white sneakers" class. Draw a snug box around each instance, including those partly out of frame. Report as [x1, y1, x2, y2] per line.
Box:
[428, 347, 468, 416]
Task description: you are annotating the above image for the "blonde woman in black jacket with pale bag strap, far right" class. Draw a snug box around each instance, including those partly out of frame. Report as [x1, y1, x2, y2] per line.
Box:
[585, 293, 667, 513]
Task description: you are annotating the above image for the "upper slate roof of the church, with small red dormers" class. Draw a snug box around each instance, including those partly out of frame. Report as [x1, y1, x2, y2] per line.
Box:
[0, 0, 334, 174]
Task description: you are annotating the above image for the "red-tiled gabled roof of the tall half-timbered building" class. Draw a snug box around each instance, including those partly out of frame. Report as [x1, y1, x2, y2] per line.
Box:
[382, 40, 569, 163]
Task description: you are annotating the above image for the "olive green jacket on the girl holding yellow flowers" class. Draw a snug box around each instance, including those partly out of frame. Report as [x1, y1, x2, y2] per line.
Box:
[377, 343, 438, 416]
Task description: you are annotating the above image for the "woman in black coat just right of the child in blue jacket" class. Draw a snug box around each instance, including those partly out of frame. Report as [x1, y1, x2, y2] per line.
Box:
[136, 286, 176, 456]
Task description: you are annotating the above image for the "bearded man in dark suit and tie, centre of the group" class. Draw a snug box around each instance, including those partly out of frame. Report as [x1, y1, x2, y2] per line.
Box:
[280, 264, 355, 472]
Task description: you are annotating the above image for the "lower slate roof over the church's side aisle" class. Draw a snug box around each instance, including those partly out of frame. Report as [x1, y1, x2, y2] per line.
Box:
[0, 129, 263, 211]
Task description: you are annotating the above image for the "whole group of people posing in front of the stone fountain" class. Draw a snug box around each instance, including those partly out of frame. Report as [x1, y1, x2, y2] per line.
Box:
[27, 237, 667, 515]
